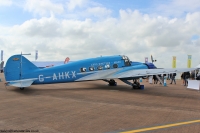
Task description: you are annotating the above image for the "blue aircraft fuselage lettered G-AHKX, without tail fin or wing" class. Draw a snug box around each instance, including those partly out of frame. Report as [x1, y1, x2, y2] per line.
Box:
[22, 55, 152, 84]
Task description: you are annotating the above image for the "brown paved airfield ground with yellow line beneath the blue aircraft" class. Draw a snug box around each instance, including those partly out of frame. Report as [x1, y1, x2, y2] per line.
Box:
[0, 73, 200, 133]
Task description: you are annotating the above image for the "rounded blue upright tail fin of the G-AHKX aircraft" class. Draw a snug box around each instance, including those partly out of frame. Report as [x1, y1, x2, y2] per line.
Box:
[4, 55, 39, 81]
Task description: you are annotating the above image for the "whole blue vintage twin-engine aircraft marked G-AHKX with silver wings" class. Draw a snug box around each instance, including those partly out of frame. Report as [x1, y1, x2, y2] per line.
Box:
[4, 54, 194, 90]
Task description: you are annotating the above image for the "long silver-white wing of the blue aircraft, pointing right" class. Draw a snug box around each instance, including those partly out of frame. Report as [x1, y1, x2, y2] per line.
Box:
[76, 67, 196, 81]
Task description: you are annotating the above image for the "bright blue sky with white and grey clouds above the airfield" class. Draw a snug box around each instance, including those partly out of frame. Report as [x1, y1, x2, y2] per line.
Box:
[0, 0, 200, 68]
